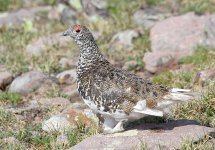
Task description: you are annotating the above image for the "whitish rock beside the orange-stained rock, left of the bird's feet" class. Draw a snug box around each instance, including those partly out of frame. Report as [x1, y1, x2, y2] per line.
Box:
[42, 115, 72, 132]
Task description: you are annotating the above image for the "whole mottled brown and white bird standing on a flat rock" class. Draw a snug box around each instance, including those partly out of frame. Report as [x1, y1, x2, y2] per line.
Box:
[63, 25, 197, 133]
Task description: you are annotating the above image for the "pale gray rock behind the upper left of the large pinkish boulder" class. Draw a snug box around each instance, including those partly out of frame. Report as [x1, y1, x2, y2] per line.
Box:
[133, 7, 171, 29]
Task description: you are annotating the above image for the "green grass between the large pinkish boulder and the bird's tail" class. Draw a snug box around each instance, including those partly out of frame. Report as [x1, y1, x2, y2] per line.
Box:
[152, 46, 215, 88]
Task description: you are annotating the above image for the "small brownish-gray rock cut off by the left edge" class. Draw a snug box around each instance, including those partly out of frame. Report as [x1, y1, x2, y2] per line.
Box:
[0, 71, 13, 89]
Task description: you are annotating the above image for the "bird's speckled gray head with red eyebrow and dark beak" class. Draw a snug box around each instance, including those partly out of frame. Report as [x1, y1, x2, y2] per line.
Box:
[63, 25, 93, 43]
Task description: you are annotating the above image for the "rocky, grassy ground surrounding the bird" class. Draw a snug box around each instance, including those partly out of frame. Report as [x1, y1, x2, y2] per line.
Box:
[0, 0, 215, 150]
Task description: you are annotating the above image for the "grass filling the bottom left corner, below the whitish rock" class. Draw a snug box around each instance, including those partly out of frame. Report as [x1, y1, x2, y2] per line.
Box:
[0, 109, 98, 150]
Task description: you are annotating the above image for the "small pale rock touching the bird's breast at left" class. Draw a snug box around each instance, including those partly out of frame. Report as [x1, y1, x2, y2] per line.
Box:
[57, 69, 77, 84]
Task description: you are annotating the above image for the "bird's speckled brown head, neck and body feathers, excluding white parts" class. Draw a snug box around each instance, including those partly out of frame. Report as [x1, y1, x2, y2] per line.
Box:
[63, 26, 169, 114]
